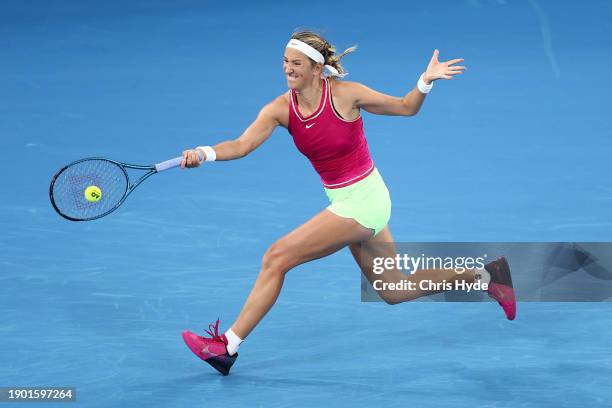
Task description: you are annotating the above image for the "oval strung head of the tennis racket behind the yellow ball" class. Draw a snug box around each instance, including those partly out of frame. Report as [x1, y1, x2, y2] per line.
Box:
[49, 157, 129, 221]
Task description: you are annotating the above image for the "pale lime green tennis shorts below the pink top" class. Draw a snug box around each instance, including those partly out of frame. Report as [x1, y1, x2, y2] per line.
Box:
[325, 169, 391, 235]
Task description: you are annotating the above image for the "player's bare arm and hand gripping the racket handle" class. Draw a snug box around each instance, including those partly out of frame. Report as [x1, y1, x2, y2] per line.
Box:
[181, 95, 288, 167]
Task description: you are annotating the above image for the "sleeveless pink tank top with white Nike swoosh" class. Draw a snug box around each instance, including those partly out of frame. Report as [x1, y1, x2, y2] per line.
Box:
[289, 79, 374, 188]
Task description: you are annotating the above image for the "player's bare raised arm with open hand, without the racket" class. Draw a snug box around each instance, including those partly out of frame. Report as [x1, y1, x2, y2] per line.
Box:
[350, 50, 465, 116]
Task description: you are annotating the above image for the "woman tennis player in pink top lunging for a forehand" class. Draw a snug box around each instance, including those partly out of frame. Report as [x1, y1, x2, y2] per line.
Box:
[181, 31, 516, 375]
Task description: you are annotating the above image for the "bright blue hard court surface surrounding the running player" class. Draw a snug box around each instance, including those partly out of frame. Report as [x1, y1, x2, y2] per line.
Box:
[0, 0, 612, 408]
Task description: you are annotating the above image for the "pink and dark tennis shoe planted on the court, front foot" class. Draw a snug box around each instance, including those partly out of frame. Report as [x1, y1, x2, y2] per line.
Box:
[183, 319, 238, 375]
